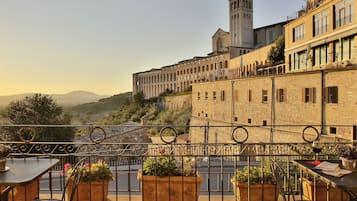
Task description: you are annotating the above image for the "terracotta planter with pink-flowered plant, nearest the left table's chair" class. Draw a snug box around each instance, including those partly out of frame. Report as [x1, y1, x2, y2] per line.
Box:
[64, 160, 113, 201]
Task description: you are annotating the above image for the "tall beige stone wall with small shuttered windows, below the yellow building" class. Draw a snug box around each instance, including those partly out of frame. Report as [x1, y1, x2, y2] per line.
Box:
[190, 69, 357, 143]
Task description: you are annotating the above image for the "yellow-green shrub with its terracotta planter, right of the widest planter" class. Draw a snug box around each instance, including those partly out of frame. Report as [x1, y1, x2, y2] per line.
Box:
[231, 166, 278, 201]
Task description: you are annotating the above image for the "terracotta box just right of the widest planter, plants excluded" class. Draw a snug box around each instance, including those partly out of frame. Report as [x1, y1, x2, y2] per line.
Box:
[231, 180, 278, 201]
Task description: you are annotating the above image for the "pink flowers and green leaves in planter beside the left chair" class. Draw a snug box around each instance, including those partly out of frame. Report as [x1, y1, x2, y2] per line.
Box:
[63, 160, 113, 182]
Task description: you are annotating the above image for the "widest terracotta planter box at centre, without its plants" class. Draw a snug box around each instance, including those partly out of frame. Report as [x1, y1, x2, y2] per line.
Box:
[138, 172, 202, 201]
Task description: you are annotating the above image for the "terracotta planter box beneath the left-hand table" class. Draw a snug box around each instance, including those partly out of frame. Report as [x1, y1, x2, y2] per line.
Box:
[0, 178, 41, 201]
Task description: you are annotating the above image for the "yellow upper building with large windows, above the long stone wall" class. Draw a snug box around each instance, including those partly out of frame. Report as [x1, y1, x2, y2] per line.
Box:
[285, 0, 357, 72]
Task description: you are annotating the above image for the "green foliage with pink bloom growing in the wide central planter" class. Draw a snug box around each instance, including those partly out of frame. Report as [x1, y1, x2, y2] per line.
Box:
[143, 148, 198, 177]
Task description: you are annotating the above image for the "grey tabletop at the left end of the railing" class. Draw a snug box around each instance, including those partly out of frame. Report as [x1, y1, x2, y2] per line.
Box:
[0, 158, 59, 200]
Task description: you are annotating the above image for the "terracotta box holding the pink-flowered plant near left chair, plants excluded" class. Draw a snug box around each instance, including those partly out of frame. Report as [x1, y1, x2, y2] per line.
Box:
[67, 181, 109, 201]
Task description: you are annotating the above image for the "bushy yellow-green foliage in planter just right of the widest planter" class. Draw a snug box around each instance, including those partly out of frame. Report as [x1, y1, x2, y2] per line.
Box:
[232, 166, 275, 185]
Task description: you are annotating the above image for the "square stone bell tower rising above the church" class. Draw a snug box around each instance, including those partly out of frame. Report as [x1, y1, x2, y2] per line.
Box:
[229, 0, 254, 58]
